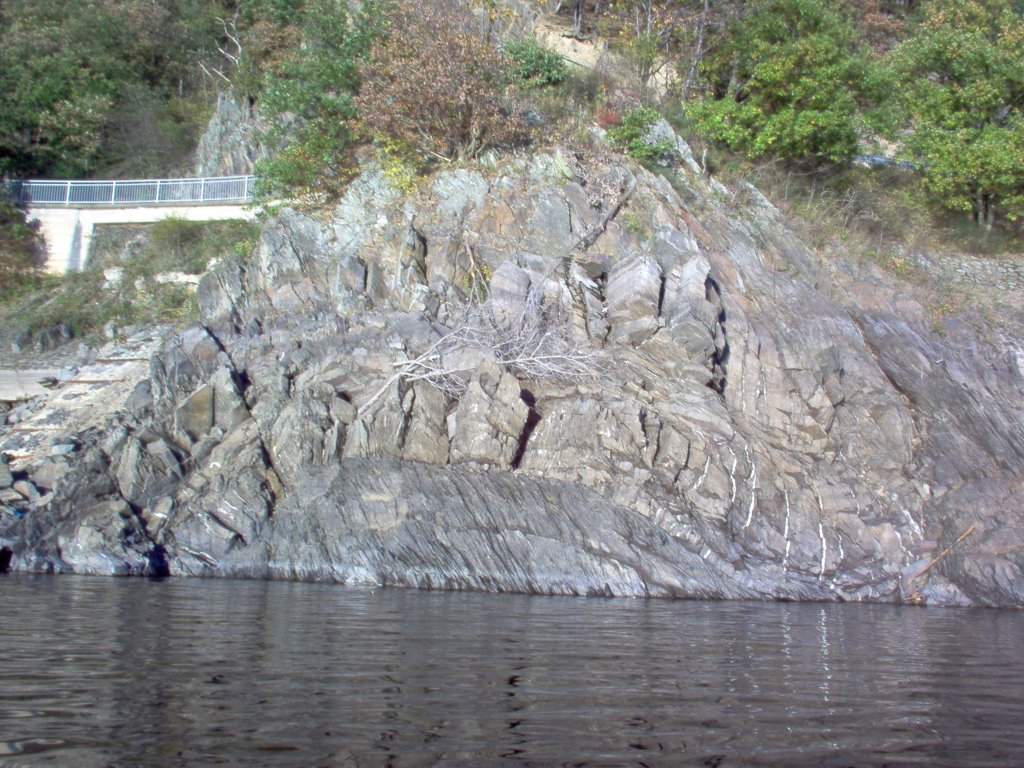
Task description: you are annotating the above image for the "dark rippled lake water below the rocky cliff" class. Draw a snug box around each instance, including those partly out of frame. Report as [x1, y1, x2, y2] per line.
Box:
[0, 574, 1024, 768]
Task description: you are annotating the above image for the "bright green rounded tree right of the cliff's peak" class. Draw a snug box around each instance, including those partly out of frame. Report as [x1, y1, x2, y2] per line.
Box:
[688, 0, 868, 161]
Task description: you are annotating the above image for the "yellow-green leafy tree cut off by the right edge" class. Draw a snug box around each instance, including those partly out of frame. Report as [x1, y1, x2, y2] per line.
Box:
[892, 0, 1024, 228]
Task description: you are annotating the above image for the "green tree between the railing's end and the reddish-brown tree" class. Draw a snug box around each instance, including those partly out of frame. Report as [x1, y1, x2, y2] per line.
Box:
[258, 0, 389, 199]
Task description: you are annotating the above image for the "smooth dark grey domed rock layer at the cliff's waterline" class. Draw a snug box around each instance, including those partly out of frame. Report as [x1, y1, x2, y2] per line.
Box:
[230, 460, 755, 597]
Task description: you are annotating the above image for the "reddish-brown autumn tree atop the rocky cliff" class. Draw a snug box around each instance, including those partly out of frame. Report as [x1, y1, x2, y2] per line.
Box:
[356, 3, 527, 160]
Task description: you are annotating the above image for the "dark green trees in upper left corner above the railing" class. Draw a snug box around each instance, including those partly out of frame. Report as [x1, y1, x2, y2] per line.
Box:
[0, 0, 224, 176]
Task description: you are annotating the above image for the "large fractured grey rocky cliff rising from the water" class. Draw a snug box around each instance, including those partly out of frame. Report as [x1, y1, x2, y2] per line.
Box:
[0, 135, 1024, 606]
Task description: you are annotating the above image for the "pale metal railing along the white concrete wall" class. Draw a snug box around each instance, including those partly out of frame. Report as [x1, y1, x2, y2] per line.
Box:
[6, 176, 256, 208]
